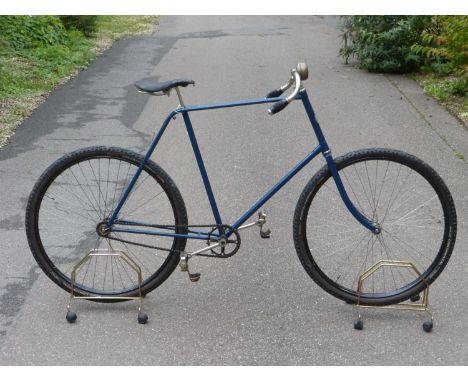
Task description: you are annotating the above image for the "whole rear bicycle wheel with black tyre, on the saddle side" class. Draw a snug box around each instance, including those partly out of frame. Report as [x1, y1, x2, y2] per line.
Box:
[26, 147, 188, 301]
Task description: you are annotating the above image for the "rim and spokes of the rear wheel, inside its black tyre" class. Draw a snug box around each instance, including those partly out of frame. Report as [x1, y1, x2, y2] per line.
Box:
[35, 154, 178, 296]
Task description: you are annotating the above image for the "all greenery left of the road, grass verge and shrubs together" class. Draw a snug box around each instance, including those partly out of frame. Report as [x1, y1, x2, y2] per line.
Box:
[0, 16, 157, 147]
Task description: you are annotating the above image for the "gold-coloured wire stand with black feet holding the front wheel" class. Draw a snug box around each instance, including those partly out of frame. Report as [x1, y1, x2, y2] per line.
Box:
[354, 260, 434, 332]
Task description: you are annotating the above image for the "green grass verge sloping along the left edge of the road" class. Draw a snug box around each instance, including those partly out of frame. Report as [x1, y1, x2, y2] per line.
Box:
[0, 16, 158, 147]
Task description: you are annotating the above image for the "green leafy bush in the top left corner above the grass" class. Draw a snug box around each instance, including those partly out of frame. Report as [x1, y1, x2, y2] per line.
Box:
[0, 16, 67, 49]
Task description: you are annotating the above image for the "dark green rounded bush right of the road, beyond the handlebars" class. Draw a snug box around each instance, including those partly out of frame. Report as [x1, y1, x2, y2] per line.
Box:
[340, 16, 430, 73]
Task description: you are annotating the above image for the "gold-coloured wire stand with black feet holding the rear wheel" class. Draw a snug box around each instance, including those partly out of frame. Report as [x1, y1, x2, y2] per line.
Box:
[66, 249, 148, 324]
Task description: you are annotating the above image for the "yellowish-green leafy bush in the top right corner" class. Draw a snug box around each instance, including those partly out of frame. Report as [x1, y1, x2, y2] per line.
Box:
[412, 16, 468, 71]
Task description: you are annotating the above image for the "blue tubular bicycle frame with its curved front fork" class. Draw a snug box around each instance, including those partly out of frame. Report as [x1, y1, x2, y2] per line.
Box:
[107, 89, 380, 240]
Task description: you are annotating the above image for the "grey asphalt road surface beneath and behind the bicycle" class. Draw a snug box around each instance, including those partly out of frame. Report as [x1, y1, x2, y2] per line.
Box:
[0, 17, 468, 365]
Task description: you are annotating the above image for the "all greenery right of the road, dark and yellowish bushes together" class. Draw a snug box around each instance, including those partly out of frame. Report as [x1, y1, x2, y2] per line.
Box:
[340, 16, 468, 125]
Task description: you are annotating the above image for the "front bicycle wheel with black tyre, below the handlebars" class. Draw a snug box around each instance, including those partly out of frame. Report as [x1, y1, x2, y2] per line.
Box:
[293, 149, 457, 305]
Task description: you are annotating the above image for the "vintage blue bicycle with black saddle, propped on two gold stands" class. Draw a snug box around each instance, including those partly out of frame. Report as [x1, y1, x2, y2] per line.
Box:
[26, 63, 457, 320]
